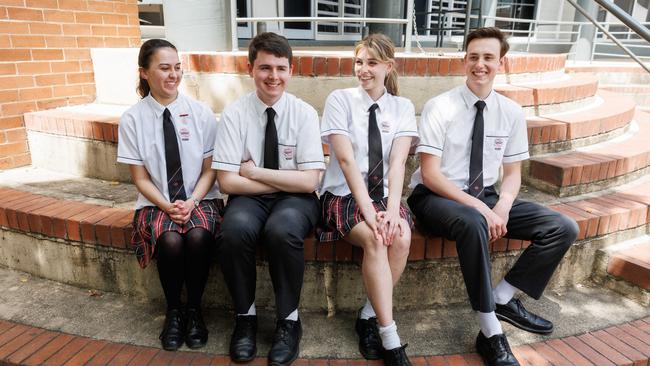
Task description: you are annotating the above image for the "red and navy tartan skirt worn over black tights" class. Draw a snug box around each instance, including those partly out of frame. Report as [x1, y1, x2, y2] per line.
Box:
[131, 199, 224, 268]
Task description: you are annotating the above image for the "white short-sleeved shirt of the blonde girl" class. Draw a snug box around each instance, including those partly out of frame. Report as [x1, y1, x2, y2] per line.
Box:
[320, 87, 418, 197]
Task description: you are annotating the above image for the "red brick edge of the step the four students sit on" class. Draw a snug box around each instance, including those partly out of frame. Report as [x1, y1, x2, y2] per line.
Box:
[0, 179, 650, 262]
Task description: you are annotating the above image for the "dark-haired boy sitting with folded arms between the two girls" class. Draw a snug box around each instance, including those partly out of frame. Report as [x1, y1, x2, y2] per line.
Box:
[212, 33, 325, 365]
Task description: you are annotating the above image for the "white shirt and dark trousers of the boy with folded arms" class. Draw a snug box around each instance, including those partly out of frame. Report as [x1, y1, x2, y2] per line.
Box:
[212, 92, 325, 319]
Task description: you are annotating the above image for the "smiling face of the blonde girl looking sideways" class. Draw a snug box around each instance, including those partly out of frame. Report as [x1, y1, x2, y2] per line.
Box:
[354, 47, 393, 100]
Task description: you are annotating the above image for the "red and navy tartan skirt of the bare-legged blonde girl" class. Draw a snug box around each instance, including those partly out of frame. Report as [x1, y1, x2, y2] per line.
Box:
[316, 192, 413, 241]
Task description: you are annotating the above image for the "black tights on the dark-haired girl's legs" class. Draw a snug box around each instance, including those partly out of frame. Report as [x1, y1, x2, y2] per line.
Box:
[156, 228, 214, 309]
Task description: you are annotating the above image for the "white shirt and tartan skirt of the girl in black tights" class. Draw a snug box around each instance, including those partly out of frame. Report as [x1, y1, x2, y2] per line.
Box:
[117, 93, 223, 268]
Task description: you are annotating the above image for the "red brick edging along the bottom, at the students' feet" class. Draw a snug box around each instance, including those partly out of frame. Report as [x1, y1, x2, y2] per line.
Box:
[0, 317, 650, 366]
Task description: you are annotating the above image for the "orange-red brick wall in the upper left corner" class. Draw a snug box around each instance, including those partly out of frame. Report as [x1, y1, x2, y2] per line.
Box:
[0, 0, 140, 169]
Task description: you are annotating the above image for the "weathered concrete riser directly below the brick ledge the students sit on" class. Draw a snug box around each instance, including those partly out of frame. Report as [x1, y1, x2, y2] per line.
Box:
[0, 229, 608, 311]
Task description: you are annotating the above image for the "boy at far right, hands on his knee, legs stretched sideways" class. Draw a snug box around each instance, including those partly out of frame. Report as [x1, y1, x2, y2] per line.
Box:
[408, 28, 578, 365]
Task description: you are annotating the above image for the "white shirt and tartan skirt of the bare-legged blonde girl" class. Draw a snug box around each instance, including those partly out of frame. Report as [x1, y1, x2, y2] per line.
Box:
[318, 87, 418, 241]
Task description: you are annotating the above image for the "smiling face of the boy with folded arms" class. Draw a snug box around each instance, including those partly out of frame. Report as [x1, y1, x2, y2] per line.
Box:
[248, 51, 293, 106]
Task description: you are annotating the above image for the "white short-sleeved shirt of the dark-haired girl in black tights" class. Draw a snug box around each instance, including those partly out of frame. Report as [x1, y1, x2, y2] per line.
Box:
[117, 93, 221, 209]
